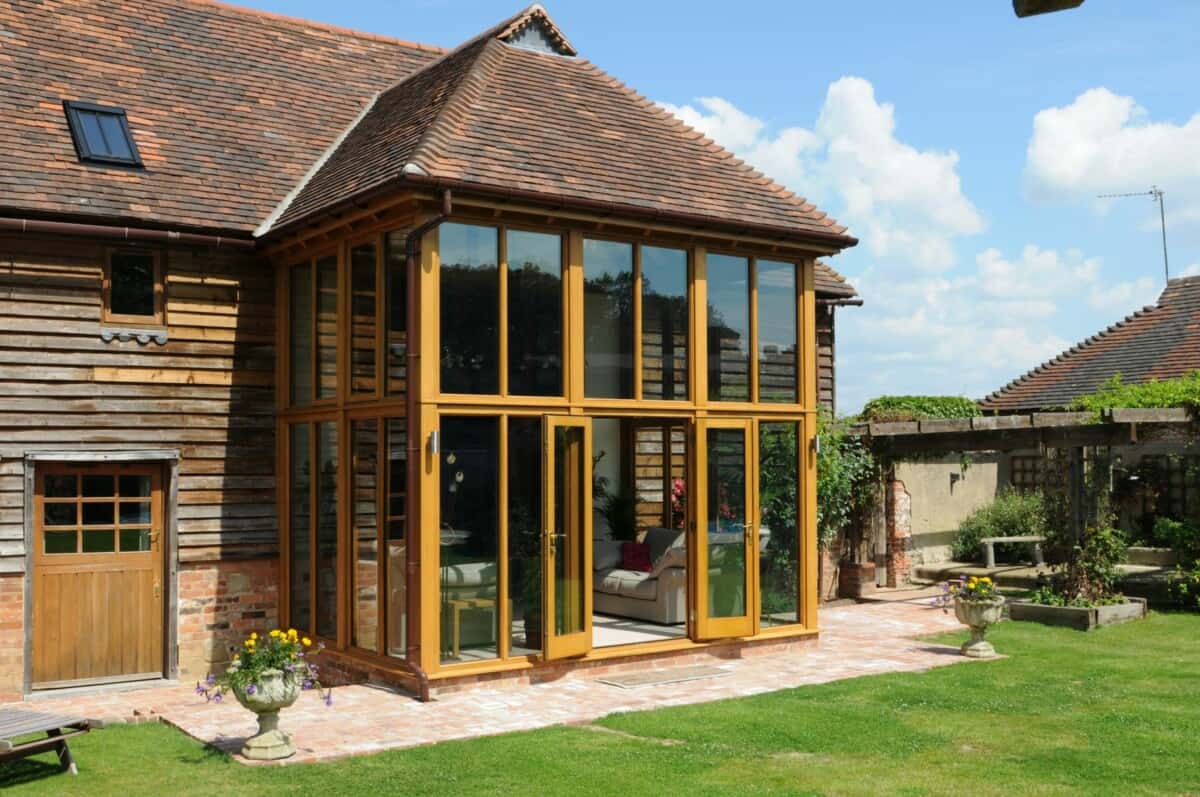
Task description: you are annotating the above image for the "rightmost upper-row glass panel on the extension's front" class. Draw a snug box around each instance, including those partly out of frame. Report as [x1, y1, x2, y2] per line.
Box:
[757, 260, 800, 405]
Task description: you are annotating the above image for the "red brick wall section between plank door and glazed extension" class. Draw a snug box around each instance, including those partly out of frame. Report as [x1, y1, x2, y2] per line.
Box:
[179, 558, 280, 681]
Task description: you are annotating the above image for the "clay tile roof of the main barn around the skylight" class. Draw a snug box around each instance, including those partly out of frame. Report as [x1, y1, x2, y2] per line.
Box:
[0, 0, 444, 234]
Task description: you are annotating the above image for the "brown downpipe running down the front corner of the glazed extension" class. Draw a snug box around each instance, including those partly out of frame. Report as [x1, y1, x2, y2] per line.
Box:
[404, 188, 451, 703]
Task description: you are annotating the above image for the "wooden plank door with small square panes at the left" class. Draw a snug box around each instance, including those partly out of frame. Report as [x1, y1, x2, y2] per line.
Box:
[32, 463, 164, 689]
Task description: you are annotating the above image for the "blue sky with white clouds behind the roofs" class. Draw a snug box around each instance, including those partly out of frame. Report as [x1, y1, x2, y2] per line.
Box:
[246, 0, 1200, 412]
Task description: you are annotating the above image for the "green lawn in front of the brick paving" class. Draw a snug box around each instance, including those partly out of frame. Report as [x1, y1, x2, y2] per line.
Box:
[7, 613, 1200, 797]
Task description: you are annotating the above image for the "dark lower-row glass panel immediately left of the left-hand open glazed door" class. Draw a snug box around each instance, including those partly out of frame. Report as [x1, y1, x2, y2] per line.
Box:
[509, 417, 542, 655]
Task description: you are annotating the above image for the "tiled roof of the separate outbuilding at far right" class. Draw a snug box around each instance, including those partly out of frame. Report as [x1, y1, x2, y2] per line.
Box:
[979, 277, 1200, 412]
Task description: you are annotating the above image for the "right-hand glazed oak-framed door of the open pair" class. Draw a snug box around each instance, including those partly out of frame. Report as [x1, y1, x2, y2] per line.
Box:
[692, 418, 758, 640]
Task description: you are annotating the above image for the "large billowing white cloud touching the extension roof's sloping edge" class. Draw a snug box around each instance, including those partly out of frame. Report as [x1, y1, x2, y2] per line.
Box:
[664, 77, 984, 272]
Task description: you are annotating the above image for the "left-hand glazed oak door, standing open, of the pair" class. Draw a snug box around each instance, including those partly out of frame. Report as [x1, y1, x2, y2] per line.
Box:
[541, 417, 592, 659]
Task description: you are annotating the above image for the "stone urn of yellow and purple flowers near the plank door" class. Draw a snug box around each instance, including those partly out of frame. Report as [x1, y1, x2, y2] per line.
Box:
[196, 628, 334, 761]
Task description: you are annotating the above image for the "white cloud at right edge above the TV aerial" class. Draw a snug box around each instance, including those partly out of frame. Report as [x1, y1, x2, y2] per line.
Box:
[1025, 88, 1200, 230]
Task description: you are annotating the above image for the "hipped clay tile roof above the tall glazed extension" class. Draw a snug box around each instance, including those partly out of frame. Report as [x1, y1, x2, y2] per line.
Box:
[271, 6, 854, 247]
